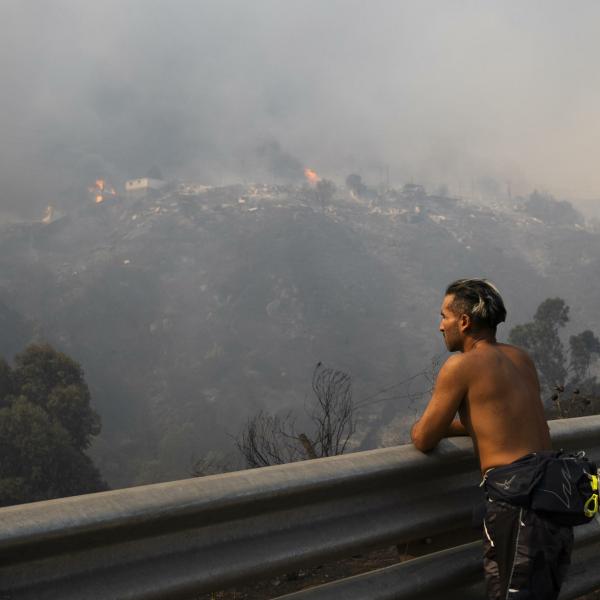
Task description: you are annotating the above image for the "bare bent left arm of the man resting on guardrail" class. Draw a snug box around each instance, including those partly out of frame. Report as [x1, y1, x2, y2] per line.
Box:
[410, 355, 468, 452]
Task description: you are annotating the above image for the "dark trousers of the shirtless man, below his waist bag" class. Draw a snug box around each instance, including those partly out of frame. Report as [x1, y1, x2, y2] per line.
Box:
[483, 500, 573, 600]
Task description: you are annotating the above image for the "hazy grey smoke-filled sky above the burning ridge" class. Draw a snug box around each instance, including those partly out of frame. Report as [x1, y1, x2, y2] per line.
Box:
[0, 0, 600, 218]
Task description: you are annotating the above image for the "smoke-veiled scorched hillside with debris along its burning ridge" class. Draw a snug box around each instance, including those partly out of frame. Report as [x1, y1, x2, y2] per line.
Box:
[0, 185, 600, 486]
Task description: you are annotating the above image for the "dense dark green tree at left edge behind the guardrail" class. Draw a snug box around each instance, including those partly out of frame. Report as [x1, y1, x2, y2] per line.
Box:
[0, 345, 106, 506]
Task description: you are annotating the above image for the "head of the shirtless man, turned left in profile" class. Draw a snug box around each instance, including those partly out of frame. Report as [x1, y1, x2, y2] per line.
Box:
[440, 279, 506, 352]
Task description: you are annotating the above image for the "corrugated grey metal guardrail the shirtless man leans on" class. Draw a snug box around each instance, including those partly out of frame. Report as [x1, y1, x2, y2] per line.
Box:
[0, 416, 600, 600]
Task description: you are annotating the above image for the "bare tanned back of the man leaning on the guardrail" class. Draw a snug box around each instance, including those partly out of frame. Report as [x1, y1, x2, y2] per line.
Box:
[456, 342, 551, 471]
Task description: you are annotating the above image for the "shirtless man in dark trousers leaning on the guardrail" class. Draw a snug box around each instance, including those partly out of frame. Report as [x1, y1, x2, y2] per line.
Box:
[411, 279, 573, 600]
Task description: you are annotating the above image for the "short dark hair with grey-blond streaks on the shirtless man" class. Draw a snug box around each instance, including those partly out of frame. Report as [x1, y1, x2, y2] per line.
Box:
[446, 279, 506, 331]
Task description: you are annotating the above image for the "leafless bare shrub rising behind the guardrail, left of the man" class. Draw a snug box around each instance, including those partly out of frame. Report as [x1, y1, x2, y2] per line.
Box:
[235, 362, 356, 468]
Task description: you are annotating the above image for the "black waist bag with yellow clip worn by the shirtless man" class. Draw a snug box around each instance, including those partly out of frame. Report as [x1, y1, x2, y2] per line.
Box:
[484, 451, 598, 525]
